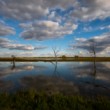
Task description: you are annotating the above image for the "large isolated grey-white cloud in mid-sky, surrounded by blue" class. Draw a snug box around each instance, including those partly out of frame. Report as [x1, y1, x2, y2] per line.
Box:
[20, 20, 77, 40]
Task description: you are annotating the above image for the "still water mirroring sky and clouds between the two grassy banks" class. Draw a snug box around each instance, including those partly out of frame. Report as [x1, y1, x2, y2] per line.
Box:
[0, 62, 110, 96]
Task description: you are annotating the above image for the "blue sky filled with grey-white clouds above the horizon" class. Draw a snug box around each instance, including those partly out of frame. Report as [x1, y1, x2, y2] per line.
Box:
[0, 0, 110, 57]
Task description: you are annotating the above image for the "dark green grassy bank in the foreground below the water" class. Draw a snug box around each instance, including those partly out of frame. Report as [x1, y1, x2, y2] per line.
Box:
[0, 90, 110, 110]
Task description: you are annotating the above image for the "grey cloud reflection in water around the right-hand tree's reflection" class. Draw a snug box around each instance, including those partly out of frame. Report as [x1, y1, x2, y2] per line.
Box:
[69, 63, 110, 81]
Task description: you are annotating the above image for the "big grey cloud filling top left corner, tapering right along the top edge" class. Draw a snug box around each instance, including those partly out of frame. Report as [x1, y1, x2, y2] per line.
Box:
[0, 0, 76, 20]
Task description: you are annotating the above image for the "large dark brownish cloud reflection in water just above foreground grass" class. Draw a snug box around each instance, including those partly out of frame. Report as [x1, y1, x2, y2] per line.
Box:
[21, 75, 78, 94]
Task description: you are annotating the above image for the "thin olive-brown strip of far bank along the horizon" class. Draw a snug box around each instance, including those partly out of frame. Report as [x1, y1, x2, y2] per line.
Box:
[0, 57, 110, 62]
